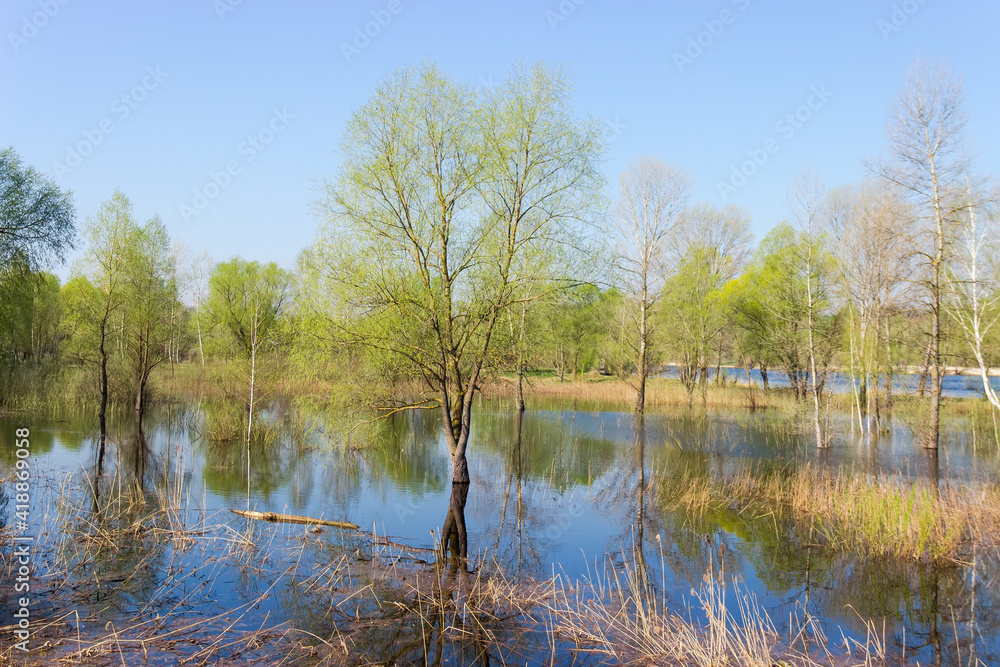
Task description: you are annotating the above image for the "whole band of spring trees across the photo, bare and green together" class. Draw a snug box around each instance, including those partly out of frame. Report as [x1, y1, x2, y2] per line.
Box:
[0, 58, 1000, 464]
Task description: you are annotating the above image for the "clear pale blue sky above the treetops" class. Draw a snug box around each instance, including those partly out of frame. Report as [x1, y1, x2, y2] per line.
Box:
[0, 0, 1000, 277]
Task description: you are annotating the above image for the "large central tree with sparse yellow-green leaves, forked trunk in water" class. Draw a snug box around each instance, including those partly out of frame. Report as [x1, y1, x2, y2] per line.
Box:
[303, 64, 600, 484]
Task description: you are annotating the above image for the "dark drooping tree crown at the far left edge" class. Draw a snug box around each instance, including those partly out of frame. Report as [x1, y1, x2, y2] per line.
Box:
[0, 148, 76, 268]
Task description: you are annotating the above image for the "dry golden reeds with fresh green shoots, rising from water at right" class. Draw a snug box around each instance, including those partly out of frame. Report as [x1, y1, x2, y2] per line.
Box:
[654, 465, 984, 560]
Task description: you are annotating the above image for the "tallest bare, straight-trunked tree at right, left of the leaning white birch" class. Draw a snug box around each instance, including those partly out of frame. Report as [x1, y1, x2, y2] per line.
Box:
[871, 60, 972, 449]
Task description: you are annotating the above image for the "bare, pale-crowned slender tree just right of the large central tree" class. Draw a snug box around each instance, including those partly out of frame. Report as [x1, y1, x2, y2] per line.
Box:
[615, 158, 691, 412]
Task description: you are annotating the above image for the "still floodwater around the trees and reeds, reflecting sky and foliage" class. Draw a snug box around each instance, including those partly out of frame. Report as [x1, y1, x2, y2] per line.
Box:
[0, 403, 1000, 664]
